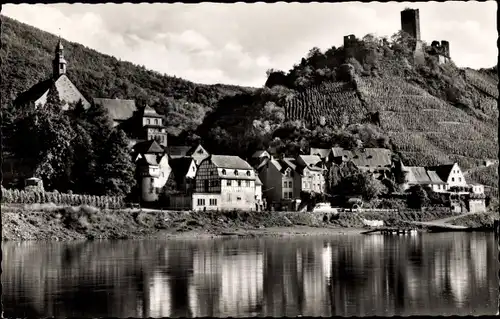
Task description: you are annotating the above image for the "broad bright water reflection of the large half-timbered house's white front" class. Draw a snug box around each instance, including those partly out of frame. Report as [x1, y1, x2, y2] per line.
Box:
[219, 252, 264, 317]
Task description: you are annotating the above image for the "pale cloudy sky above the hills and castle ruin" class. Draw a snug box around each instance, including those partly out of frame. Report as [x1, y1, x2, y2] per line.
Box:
[2, 1, 498, 87]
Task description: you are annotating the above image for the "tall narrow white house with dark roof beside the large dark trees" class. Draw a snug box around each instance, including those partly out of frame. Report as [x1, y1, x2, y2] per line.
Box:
[132, 140, 171, 202]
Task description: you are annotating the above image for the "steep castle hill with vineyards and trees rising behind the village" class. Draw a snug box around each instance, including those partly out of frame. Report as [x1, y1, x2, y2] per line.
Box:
[201, 32, 498, 190]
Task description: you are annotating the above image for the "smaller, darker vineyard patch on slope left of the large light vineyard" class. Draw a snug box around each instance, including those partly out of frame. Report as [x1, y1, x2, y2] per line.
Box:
[285, 82, 367, 126]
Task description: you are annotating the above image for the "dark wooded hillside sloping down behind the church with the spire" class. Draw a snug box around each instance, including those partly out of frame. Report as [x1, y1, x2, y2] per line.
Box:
[0, 15, 253, 140]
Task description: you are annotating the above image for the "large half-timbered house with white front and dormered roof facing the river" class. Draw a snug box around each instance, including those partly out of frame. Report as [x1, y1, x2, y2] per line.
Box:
[192, 155, 256, 210]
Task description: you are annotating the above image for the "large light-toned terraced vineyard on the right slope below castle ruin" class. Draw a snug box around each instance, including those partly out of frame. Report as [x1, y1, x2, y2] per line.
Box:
[358, 75, 498, 172]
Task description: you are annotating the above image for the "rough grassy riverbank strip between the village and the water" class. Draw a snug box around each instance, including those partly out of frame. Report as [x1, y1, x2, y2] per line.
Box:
[2, 204, 492, 240]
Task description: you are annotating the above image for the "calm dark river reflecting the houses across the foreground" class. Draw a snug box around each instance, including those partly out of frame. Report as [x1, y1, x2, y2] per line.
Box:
[1, 232, 498, 317]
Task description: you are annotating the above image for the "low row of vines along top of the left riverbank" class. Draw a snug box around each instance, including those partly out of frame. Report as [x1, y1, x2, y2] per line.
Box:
[2, 187, 125, 209]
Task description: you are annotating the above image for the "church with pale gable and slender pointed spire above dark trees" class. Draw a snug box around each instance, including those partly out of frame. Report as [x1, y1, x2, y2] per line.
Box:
[14, 39, 90, 110]
